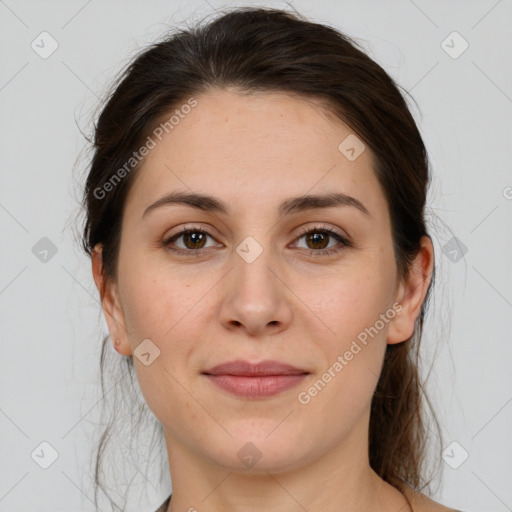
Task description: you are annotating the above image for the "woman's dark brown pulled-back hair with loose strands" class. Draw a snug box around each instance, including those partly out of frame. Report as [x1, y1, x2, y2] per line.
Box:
[82, 7, 441, 512]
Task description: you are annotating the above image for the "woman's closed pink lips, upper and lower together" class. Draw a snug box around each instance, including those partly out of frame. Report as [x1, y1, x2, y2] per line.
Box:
[203, 359, 309, 398]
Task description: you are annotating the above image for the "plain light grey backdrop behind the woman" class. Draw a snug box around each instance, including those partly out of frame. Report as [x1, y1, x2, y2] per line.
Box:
[0, 0, 512, 512]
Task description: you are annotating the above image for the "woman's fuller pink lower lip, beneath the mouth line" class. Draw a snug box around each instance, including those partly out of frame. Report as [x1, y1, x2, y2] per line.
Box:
[206, 374, 308, 398]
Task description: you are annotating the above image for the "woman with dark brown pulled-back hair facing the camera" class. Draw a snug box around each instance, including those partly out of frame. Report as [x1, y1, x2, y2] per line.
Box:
[83, 8, 464, 512]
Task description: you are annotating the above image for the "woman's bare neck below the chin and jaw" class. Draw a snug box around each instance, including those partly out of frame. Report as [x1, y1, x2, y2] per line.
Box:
[166, 412, 409, 512]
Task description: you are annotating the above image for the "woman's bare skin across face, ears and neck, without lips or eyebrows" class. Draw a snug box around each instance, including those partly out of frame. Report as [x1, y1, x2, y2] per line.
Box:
[92, 90, 436, 512]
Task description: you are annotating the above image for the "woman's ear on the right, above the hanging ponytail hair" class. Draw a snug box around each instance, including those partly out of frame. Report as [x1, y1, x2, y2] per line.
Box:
[387, 236, 434, 344]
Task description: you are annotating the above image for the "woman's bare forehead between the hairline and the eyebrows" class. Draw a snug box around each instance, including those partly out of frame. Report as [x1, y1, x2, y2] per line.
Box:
[123, 90, 385, 220]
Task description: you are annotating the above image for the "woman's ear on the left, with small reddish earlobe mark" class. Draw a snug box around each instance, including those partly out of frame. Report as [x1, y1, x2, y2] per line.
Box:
[91, 244, 132, 356]
